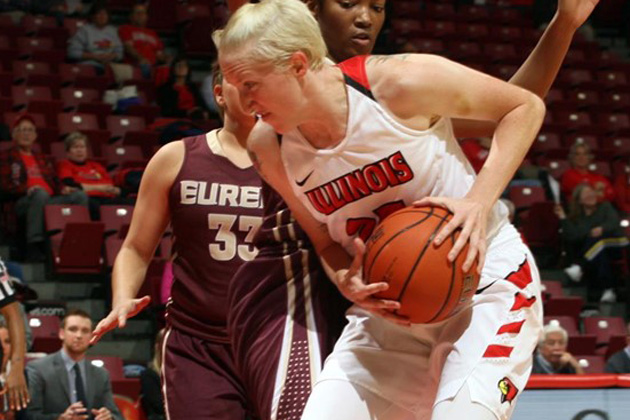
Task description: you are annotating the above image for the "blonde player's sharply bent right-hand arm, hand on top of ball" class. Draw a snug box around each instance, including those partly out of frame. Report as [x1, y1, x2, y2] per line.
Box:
[367, 54, 545, 271]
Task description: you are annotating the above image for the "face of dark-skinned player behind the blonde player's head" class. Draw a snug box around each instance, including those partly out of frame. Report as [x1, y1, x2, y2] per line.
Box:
[313, 0, 386, 62]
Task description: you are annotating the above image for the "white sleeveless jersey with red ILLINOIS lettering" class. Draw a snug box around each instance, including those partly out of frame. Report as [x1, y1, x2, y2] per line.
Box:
[281, 61, 508, 254]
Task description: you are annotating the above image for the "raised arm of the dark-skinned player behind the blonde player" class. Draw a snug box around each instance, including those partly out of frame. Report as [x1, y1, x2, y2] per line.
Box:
[453, 0, 599, 138]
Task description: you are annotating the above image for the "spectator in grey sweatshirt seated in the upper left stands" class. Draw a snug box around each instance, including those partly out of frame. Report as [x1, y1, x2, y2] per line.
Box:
[68, 2, 123, 74]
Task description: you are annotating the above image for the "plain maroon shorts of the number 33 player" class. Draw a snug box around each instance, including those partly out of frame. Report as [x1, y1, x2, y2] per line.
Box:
[162, 327, 253, 420]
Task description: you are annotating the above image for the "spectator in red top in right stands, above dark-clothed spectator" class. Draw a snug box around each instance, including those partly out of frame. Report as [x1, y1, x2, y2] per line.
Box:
[560, 142, 615, 203]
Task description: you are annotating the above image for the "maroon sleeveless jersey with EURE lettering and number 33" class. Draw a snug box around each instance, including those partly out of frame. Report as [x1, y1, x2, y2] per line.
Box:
[168, 135, 262, 342]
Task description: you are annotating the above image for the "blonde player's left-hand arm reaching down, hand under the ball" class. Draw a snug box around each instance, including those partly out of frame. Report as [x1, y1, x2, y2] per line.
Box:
[247, 121, 409, 325]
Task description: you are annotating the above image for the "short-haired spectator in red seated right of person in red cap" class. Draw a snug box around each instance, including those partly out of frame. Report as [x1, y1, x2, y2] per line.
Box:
[57, 131, 133, 220]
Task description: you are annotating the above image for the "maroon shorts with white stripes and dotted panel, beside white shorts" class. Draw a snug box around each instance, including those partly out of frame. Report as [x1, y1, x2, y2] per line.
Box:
[228, 249, 349, 420]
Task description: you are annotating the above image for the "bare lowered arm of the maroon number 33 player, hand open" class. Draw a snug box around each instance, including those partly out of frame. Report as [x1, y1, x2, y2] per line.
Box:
[90, 141, 185, 344]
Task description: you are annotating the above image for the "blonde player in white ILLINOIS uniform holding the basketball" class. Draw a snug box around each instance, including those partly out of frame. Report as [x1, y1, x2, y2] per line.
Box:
[217, 0, 592, 420]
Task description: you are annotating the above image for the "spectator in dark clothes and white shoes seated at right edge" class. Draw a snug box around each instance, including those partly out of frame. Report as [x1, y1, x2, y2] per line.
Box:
[556, 184, 629, 302]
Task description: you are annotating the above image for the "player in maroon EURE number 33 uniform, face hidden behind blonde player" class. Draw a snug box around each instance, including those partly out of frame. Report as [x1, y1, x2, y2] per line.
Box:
[93, 67, 262, 420]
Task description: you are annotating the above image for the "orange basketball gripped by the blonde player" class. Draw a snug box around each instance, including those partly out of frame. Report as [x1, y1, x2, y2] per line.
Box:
[363, 207, 479, 324]
